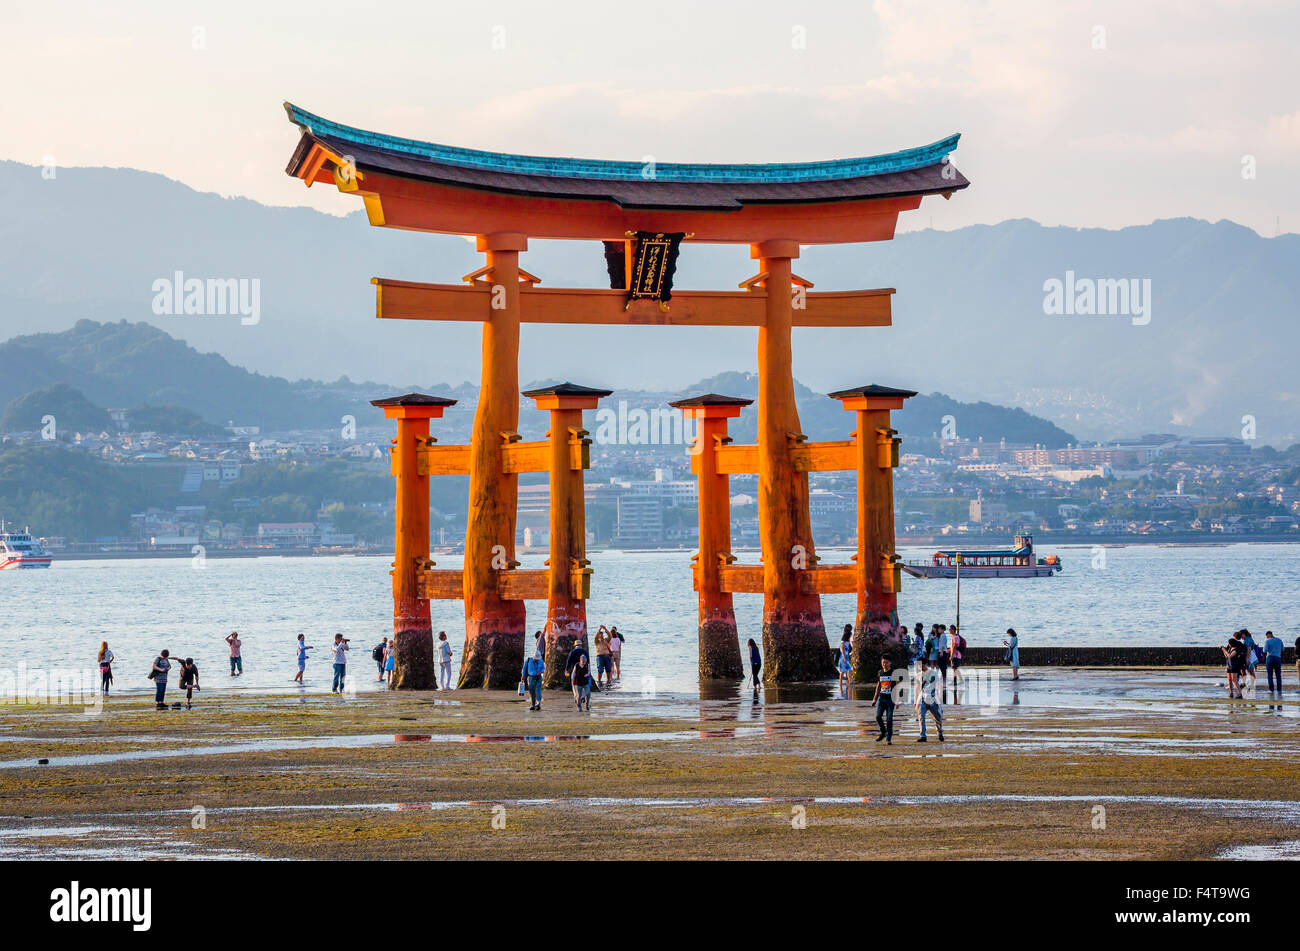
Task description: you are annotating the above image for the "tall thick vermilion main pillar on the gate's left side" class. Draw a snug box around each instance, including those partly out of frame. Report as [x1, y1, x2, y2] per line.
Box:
[458, 233, 528, 689]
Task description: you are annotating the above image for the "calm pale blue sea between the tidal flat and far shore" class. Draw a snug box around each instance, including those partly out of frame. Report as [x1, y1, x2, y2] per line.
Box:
[0, 544, 1300, 692]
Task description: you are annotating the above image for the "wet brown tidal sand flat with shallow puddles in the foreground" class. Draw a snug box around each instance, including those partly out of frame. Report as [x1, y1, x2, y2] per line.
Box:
[0, 669, 1300, 860]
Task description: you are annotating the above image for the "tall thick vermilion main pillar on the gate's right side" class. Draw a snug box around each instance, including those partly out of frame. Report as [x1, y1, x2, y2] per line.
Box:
[750, 240, 831, 683]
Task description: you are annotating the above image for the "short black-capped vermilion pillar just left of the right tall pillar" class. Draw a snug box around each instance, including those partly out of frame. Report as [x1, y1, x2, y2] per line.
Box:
[670, 394, 753, 681]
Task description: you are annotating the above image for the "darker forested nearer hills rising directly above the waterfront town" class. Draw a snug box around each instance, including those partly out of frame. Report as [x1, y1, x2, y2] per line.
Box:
[0, 320, 1074, 447]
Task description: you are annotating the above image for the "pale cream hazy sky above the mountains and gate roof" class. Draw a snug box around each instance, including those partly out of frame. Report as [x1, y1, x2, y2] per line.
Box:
[0, 0, 1300, 235]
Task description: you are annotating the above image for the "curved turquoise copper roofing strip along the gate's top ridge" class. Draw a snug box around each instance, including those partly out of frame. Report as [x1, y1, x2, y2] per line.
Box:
[285, 103, 961, 183]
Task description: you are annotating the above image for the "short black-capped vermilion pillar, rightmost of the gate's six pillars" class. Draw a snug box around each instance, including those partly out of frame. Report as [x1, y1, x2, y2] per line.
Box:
[831, 383, 917, 683]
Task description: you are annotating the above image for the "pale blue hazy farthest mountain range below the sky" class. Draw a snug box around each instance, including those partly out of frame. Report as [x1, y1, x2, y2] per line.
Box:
[0, 162, 1300, 446]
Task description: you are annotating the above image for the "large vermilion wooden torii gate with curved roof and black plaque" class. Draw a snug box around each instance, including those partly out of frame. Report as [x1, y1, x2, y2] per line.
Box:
[285, 103, 969, 687]
